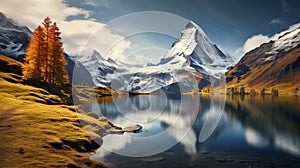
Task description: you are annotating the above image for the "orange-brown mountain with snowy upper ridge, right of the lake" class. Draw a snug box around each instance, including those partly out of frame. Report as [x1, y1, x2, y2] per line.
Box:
[226, 27, 300, 93]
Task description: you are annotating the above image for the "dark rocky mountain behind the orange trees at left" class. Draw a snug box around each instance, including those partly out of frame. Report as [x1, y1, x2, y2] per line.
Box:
[0, 12, 94, 85]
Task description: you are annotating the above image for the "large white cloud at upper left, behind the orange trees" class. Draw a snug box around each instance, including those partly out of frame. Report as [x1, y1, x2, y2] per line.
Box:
[0, 0, 130, 57]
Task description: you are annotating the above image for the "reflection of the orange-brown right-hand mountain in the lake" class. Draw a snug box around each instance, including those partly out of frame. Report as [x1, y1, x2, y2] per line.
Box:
[225, 96, 300, 155]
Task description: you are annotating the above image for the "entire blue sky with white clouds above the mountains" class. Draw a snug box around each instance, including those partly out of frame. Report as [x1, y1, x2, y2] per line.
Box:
[0, 0, 300, 63]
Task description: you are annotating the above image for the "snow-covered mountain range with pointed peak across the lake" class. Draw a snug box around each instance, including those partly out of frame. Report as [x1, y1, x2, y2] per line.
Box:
[88, 22, 234, 92]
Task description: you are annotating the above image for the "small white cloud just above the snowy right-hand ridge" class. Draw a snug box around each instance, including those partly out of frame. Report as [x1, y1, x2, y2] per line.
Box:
[233, 23, 300, 57]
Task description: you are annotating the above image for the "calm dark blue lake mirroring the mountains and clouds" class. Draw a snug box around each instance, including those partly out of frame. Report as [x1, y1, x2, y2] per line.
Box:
[91, 95, 300, 167]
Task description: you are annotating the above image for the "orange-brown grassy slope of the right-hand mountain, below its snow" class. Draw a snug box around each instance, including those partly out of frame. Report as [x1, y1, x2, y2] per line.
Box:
[226, 48, 300, 95]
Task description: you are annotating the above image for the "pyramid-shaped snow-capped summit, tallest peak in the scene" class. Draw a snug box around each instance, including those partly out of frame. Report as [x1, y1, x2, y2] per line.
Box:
[160, 21, 234, 77]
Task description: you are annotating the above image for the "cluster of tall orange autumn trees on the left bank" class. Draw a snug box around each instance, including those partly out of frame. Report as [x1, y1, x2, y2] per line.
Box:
[23, 17, 69, 85]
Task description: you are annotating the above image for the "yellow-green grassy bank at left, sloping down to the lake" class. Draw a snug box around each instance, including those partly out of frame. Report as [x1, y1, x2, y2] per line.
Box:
[0, 56, 109, 168]
